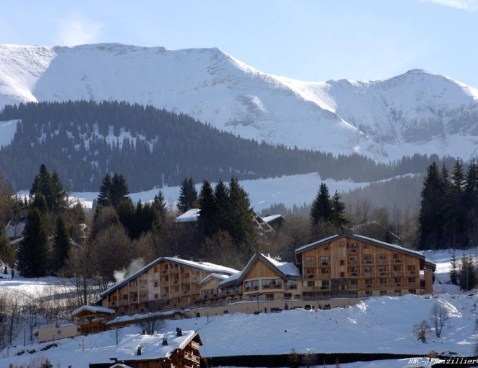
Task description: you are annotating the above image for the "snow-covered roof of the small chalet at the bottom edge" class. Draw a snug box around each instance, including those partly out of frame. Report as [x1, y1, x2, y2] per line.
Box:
[91, 330, 202, 365]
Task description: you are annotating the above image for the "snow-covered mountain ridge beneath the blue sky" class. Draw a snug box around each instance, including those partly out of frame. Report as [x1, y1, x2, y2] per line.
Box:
[0, 44, 478, 160]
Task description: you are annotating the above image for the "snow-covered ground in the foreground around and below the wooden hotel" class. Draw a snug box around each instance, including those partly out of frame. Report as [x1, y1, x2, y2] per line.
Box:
[0, 249, 478, 368]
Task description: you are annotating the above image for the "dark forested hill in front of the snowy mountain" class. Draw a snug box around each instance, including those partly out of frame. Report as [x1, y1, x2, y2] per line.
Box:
[0, 101, 452, 192]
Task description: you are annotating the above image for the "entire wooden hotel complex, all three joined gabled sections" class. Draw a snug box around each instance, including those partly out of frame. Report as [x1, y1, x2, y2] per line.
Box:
[91, 235, 435, 315]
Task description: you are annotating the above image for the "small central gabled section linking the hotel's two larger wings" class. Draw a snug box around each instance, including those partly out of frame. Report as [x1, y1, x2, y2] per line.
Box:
[219, 253, 302, 301]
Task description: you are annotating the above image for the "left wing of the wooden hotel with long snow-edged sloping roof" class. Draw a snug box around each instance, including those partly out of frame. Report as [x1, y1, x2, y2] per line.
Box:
[97, 257, 239, 315]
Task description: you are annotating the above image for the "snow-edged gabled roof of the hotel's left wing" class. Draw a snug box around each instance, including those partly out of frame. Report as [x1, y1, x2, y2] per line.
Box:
[97, 257, 239, 303]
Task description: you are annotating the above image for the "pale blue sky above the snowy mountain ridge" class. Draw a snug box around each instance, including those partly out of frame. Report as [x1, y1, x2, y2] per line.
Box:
[0, 0, 478, 88]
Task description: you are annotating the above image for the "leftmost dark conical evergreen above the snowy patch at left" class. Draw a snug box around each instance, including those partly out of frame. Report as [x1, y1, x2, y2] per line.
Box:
[17, 209, 49, 277]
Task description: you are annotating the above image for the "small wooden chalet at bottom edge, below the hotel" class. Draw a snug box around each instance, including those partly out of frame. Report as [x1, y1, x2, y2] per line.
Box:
[90, 328, 202, 368]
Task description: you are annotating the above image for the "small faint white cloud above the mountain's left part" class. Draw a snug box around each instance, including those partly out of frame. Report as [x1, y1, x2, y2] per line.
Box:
[59, 14, 103, 46]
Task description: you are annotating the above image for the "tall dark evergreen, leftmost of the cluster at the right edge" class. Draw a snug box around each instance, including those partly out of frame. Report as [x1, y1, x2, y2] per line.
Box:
[418, 162, 445, 249]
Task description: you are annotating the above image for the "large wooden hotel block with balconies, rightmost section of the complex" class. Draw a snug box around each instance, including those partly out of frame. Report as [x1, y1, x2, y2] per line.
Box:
[295, 235, 435, 300]
